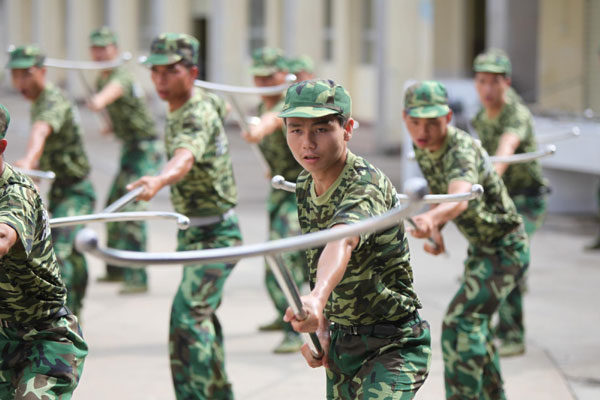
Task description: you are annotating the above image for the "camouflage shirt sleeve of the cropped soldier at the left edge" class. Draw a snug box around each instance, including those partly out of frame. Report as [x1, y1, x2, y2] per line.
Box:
[0, 193, 36, 256]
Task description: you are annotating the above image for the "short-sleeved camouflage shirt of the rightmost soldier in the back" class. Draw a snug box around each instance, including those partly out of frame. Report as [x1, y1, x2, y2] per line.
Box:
[471, 100, 546, 195]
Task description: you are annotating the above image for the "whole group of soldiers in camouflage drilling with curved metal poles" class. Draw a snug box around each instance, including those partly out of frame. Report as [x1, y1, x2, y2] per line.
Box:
[0, 24, 546, 399]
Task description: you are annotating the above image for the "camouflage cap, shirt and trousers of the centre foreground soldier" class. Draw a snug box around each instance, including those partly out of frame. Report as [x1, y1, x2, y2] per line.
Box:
[280, 80, 431, 399]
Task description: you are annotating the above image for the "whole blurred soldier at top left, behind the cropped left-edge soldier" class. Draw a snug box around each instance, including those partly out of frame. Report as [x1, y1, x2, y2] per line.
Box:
[7, 46, 96, 316]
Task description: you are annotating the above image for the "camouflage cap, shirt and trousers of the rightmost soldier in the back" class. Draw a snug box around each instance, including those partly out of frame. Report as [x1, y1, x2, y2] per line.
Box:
[471, 54, 547, 344]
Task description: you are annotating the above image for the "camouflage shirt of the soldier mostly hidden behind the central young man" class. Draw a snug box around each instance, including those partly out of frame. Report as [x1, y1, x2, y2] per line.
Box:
[258, 97, 302, 182]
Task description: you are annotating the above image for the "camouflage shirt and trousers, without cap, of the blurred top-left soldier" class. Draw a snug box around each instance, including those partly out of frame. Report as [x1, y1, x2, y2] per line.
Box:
[31, 83, 96, 315]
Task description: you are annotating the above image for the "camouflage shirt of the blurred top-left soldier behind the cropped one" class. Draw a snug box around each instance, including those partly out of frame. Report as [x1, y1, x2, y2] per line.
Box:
[31, 83, 90, 185]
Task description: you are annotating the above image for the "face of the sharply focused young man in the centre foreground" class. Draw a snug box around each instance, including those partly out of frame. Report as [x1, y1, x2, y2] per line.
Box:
[286, 115, 352, 173]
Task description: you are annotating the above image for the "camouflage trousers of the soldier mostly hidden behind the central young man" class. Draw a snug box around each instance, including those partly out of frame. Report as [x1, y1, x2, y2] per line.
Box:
[265, 189, 308, 332]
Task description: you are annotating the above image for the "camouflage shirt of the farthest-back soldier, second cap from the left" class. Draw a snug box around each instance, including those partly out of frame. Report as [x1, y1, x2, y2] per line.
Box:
[96, 67, 158, 143]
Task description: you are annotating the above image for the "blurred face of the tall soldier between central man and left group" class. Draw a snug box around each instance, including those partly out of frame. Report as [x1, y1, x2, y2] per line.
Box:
[151, 62, 198, 103]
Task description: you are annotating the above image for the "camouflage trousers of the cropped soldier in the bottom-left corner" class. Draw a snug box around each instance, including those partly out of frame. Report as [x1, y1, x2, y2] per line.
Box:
[0, 315, 88, 400]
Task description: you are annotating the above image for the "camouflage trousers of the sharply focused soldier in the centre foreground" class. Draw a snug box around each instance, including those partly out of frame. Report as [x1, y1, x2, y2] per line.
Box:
[326, 317, 431, 400]
